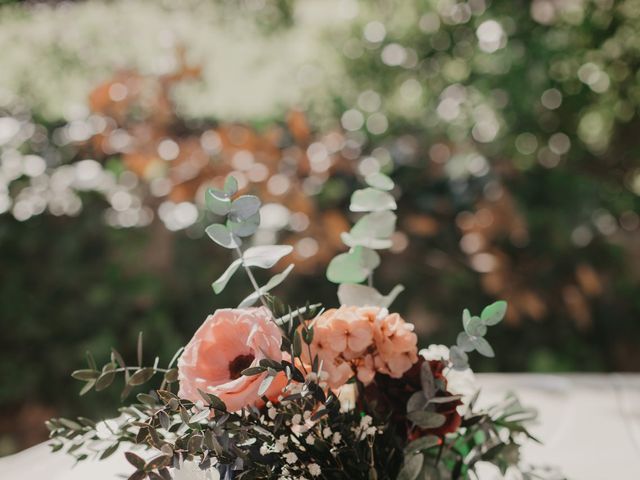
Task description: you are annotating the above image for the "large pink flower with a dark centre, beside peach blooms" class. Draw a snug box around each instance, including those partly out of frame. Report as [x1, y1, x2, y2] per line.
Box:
[178, 307, 287, 411]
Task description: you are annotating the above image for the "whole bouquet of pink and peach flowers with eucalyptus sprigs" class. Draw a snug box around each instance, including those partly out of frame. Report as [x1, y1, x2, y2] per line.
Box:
[48, 173, 537, 480]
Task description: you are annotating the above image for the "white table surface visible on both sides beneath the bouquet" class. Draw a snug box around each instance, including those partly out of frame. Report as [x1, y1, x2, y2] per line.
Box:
[0, 374, 640, 480]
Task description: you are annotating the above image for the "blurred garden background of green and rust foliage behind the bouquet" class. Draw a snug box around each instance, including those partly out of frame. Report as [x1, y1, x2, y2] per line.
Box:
[0, 0, 640, 455]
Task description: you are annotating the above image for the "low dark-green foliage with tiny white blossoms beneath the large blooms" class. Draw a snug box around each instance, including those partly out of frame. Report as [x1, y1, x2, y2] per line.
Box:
[47, 296, 534, 480]
